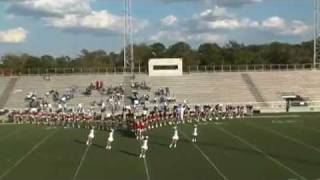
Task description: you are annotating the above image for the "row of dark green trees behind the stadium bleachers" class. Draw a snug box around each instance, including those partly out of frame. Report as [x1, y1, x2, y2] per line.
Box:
[0, 41, 313, 71]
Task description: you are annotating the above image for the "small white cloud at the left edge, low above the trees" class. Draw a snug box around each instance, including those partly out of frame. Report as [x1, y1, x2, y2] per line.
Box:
[0, 27, 28, 44]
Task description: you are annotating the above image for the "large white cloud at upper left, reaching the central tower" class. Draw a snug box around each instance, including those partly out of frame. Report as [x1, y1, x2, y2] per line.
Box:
[8, 0, 148, 35]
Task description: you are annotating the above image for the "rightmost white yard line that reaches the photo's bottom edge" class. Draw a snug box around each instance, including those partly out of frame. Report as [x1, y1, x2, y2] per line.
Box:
[214, 126, 307, 180]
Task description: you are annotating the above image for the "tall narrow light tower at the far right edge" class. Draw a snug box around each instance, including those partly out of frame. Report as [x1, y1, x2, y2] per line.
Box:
[313, 0, 320, 68]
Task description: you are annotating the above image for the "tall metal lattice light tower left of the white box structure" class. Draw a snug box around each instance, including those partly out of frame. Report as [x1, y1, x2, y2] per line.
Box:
[123, 0, 134, 78]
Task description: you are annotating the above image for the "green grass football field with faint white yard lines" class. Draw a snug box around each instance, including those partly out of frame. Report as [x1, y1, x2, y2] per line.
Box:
[0, 113, 320, 180]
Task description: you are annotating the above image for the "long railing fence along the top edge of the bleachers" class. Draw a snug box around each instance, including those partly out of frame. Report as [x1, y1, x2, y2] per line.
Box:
[0, 64, 320, 76]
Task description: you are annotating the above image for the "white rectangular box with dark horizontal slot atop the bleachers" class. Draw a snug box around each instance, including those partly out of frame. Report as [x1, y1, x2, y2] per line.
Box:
[148, 58, 183, 76]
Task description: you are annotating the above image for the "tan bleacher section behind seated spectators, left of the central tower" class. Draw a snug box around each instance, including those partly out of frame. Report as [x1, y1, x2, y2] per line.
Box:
[5, 75, 123, 108]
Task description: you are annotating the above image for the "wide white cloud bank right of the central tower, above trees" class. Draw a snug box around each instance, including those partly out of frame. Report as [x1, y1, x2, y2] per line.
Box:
[150, 6, 311, 44]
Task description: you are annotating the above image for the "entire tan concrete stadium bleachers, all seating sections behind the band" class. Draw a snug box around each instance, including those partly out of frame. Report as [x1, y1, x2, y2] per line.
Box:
[0, 71, 320, 108]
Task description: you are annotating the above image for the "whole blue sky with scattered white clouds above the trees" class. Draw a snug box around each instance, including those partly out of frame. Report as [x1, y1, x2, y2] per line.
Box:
[0, 0, 313, 56]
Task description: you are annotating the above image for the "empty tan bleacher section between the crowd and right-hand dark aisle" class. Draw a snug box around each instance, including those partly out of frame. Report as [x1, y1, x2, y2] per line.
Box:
[137, 73, 255, 104]
